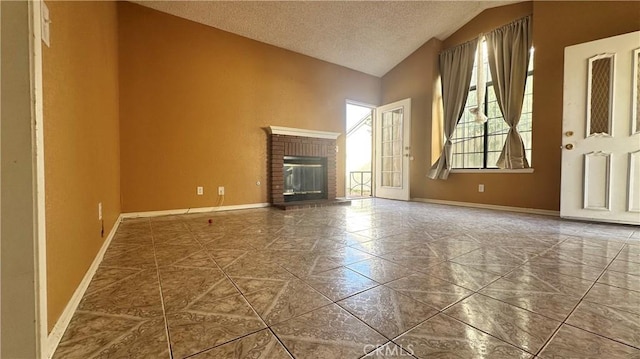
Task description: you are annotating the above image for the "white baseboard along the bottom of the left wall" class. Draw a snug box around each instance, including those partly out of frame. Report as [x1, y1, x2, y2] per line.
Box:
[45, 214, 123, 358]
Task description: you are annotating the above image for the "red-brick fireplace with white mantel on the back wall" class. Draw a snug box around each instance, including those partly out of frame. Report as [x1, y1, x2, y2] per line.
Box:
[268, 126, 340, 206]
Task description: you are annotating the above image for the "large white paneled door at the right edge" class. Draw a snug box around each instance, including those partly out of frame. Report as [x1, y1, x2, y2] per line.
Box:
[560, 32, 640, 224]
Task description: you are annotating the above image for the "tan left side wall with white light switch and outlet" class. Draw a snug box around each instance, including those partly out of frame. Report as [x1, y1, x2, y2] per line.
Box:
[43, 2, 120, 329]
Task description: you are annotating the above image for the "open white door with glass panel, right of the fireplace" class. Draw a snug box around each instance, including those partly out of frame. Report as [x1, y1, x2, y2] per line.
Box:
[374, 99, 411, 201]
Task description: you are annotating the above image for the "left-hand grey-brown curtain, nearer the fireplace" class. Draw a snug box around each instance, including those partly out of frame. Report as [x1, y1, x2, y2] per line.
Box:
[428, 39, 478, 179]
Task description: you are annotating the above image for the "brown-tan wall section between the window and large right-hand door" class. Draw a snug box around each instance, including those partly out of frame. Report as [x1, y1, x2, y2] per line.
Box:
[533, 1, 640, 210]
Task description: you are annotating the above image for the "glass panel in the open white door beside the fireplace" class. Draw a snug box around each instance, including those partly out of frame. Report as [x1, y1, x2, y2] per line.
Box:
[380, 108, 402, 188]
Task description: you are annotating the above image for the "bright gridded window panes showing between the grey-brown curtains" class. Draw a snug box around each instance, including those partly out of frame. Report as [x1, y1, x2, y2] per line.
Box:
[451, 41, 533, 169]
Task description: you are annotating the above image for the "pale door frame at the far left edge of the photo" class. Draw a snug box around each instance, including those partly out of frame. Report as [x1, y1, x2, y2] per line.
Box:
[0, 0, 50, 358]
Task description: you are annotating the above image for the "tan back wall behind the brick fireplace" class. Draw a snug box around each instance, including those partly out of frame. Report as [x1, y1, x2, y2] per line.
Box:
[118, 3, 380, 212]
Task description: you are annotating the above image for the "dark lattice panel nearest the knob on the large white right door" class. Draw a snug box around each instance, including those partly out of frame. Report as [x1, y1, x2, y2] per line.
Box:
[587, 54, 615, 137]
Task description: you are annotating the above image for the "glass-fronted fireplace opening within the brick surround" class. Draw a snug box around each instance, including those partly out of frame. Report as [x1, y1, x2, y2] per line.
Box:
[283, 156, 327, 202]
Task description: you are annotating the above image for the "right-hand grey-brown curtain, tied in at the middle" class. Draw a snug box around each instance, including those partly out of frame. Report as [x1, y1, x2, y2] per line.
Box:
[485, 16, 532, 169]
